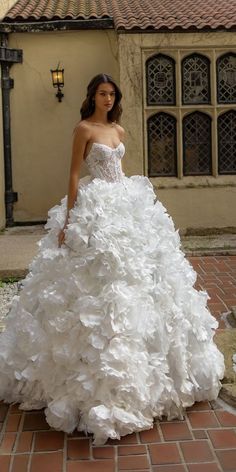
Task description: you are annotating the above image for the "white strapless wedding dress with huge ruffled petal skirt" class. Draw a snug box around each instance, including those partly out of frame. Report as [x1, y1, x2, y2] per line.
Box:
[0, 143, 224, 444]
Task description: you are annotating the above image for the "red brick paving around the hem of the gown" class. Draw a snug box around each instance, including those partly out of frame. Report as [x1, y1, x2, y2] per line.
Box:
[0, 256, 236, 472]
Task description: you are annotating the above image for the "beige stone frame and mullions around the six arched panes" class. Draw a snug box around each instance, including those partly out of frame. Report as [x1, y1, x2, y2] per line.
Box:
[142, 46, 236, 188]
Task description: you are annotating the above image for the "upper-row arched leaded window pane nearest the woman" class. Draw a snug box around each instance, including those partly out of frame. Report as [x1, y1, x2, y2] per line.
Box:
[146, 54, 175, 105]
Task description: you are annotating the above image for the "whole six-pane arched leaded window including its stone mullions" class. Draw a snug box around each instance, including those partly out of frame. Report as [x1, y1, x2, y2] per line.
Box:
[143, 47, 236, 179]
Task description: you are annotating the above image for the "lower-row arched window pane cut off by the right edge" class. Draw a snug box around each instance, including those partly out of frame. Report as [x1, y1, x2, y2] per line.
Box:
[218, 110, 236, 174]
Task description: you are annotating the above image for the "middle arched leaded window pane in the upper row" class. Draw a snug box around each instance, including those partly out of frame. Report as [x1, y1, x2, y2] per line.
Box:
[182, 54, 211, 105]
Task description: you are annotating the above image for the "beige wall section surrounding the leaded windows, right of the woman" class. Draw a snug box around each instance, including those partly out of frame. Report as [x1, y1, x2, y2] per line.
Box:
[119, 32, 236, 230]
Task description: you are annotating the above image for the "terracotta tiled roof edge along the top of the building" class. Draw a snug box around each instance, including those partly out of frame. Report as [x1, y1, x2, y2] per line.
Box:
[3, 0, 236, 31]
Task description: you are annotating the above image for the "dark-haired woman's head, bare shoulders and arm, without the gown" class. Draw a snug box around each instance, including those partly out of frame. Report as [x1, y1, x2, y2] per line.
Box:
[59, 74, 124, 246]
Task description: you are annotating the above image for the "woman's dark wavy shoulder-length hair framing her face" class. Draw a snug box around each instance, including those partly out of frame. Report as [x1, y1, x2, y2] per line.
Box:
[80, 74, 122, 122]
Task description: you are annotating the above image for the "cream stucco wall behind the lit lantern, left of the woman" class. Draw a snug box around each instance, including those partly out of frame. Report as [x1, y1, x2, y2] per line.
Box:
[9, 31, 119, 222]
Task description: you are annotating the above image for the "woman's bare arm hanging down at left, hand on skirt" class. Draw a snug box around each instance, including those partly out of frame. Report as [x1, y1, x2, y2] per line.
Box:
[58, 123, 90, 247]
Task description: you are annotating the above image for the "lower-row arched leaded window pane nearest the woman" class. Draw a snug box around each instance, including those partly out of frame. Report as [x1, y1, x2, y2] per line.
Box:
[147, 112, 177, 177]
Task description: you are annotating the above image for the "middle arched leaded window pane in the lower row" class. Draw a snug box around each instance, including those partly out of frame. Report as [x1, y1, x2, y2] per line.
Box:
[183, 112, 212, 175]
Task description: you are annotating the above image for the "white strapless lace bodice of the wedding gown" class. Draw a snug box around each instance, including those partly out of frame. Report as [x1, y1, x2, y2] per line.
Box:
[86, 142, 125, 182]
